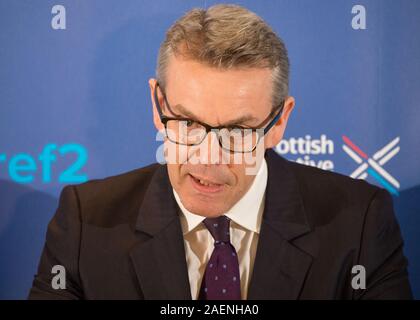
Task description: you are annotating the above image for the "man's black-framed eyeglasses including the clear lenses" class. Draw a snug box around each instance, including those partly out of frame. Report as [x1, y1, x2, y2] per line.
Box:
[154, 83, 284, 153]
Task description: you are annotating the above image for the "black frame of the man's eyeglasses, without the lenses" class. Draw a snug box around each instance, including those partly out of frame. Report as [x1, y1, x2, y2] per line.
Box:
[153, 82, 284, 153]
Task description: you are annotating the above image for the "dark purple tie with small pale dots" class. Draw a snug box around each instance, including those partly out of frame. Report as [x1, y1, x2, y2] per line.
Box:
[198, 216, 241, 300]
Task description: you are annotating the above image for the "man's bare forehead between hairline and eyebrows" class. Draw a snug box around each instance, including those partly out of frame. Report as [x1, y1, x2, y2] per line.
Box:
[166, 56, 273, 112]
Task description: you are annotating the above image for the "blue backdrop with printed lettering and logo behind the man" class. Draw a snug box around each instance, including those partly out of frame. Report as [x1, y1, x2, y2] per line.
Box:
[0, 0, 420, 299]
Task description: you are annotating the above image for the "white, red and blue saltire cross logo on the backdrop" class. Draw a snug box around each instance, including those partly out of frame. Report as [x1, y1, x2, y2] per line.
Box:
[343, 136, 400, 196]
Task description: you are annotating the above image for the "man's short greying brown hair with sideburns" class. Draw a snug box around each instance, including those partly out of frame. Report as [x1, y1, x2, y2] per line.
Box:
[156, 4, 289, 107]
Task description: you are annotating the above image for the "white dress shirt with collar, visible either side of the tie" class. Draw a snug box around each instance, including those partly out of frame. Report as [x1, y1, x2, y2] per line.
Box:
[173, 159, 268, 300]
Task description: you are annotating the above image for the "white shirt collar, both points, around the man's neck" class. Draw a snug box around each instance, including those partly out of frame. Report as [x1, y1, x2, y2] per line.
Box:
[172, 159, 268, 235]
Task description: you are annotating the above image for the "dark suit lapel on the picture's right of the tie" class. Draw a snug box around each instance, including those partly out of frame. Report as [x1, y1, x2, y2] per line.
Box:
[248, 150, 313, 299]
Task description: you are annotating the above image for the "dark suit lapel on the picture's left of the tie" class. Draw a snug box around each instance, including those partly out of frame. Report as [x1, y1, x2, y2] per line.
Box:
[130, 166, 191, 300]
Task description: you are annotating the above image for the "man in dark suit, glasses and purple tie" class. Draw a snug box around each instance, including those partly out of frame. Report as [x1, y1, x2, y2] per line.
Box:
[29, 5, 411, 300]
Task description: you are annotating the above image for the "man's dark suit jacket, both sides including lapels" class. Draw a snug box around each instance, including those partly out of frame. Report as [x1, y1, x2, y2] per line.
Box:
[29, 150, 411, 299]
